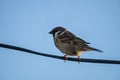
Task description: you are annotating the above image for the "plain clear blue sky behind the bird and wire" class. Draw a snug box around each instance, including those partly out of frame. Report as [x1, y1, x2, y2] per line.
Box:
[0, 0, 120, 80]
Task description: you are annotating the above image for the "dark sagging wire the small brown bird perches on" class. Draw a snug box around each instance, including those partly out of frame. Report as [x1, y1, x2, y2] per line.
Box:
[0, 43, 120, 64]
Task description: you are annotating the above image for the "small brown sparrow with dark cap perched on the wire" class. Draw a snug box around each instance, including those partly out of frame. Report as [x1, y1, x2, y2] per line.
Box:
[49, 26, 102, 62]
